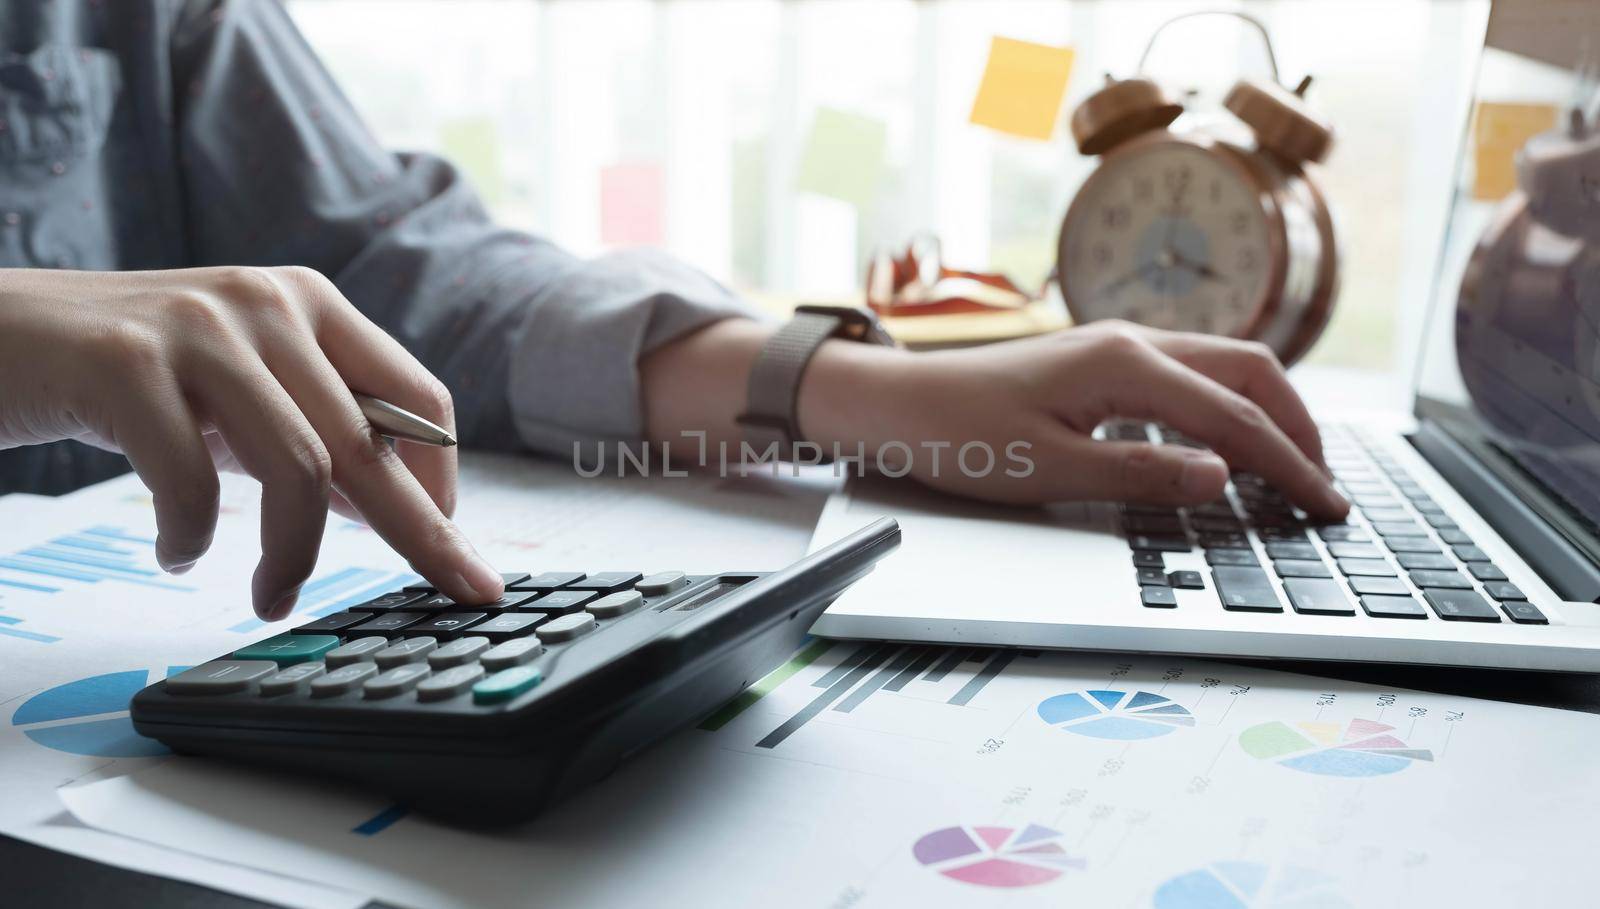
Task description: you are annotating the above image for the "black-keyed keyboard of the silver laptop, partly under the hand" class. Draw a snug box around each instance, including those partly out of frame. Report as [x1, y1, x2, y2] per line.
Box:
[1102, 421, 1549, 624]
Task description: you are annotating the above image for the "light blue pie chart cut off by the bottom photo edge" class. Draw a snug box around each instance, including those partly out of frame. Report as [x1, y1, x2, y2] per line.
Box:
[1152, 861, 1350, 909]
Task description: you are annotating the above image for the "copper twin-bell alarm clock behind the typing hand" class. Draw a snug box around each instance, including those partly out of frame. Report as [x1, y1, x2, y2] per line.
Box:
[1056, 26, 1339, 363]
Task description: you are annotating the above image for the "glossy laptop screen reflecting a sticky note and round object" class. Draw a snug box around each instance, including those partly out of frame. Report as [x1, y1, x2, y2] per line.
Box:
[1418, 0, 1600, 525]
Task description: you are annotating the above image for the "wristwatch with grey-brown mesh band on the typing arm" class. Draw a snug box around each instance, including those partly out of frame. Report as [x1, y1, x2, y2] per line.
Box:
[738, 306, 898, 451]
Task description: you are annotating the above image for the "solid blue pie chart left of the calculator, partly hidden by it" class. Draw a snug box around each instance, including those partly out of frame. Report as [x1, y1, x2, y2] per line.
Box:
[11, 666, 189, 757]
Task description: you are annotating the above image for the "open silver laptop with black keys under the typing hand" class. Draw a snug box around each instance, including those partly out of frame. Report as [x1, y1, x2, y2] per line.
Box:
[813, 2, 1600, 672]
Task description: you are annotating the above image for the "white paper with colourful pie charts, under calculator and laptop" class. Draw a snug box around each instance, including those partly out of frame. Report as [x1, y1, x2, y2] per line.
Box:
[64, 640, 1600, 909]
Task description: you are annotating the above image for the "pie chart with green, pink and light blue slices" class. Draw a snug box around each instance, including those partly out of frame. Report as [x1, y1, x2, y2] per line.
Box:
[1238, 720, 1434, 776]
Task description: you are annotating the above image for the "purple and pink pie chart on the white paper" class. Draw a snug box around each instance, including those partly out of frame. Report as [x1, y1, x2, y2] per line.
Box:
[910, 824, 1083, 887]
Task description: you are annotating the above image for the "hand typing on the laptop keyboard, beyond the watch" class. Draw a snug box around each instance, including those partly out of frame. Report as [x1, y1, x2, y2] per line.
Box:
[798, 322, 1349, 520]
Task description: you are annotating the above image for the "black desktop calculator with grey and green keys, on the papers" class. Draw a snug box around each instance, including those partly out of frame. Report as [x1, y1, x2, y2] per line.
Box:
[131, 519, 901, 824]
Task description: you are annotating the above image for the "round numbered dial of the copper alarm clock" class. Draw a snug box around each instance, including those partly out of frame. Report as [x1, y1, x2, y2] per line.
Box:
[1062, 141, 1275, 334]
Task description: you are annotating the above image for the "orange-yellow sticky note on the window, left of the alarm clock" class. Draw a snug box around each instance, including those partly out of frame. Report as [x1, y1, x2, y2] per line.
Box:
[971, 37, 1072, 139]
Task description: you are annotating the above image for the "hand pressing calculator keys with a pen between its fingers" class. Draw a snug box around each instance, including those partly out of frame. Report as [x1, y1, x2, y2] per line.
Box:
[0, 267, 501, 621]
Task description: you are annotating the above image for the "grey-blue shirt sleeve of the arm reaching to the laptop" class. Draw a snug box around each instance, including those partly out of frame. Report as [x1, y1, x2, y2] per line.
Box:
[171, 0, 752, 456]
